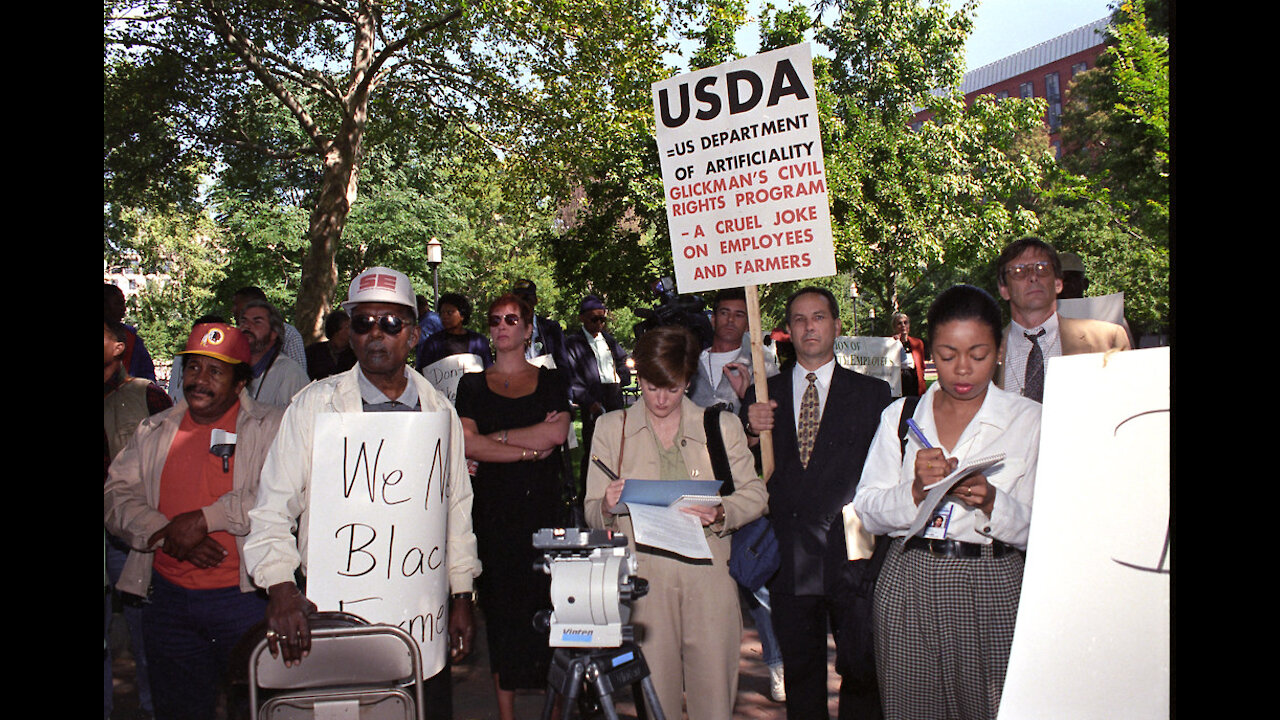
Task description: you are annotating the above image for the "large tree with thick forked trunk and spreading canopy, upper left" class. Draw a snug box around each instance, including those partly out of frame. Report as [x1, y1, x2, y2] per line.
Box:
[104, 0, 691, 337]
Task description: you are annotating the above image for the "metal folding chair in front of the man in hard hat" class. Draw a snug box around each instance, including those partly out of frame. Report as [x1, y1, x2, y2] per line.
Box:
[248, 612, 425, 720]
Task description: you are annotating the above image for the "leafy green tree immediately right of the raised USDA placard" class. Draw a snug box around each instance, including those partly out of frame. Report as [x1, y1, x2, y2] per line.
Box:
[818, 0, 1050, 334]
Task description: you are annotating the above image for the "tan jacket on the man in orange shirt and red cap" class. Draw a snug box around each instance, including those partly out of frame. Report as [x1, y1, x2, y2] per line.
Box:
[102, 391, 284, 597]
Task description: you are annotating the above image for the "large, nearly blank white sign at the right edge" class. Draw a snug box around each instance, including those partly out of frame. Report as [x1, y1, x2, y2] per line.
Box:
[998, 347, 1172, 720]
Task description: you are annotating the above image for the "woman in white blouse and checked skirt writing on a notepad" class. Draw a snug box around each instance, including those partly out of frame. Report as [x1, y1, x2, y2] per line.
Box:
[854, 286, 1041, 720]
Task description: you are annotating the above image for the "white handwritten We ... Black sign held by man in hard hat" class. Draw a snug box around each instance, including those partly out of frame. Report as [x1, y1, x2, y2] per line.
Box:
[307, 411, 449, 678]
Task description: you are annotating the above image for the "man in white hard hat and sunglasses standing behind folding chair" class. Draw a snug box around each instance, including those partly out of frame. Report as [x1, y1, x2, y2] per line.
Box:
[244, 268, 480, 719]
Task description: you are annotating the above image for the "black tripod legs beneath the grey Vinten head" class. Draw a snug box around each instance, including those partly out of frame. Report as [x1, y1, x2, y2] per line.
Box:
[543, 642, 666, 720]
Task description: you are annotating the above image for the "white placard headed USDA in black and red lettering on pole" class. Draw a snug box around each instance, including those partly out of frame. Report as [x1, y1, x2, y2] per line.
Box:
[653, 42, 836, 293]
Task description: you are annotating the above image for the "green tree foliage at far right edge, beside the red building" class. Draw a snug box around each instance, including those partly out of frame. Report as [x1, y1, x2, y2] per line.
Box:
[1036, 3, 1170, 333]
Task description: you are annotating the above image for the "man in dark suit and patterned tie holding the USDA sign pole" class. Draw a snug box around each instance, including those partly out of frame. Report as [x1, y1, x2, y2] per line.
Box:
[744, 287, 891, 720]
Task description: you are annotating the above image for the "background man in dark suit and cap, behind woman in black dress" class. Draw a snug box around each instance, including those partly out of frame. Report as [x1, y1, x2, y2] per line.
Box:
[564, 295, 631, 487]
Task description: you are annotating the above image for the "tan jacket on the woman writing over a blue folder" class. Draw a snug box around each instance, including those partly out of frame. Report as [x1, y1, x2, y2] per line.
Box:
[584, 397, 769, 561]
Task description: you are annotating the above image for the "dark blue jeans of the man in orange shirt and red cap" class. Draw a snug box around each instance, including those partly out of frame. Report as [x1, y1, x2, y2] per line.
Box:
[142, 574, 266, 720]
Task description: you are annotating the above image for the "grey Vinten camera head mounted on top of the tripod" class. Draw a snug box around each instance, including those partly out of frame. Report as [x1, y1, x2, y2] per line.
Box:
[534, 528, 649, 647]
